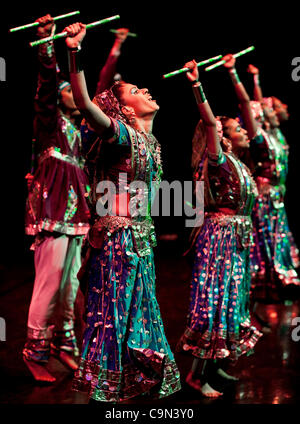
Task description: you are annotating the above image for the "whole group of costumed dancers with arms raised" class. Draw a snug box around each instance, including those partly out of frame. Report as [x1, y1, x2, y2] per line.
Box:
[23, 15, 300, 402]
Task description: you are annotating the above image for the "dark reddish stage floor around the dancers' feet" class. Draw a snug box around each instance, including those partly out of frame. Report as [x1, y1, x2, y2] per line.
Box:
[0, 241, 300, 407]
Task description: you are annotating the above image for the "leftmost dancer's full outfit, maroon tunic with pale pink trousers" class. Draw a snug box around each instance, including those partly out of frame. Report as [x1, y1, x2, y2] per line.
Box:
[23, 43, 90, 363]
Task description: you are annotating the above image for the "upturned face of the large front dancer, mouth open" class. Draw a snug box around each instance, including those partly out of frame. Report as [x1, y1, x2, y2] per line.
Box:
[122, 84, 159, 118]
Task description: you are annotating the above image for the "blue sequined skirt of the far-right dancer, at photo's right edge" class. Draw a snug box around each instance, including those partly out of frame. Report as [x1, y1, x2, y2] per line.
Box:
[250, 192, 300, 301]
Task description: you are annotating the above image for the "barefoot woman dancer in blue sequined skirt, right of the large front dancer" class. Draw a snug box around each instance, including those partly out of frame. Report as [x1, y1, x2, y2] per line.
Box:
[177, 61, 261, 397]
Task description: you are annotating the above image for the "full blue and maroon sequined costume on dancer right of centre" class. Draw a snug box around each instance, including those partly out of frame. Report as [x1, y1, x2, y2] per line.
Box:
[177, 121, 262, 361]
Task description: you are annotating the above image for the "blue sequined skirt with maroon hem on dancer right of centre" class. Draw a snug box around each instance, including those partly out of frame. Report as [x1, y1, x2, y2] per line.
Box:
[177, 216, 262, 360]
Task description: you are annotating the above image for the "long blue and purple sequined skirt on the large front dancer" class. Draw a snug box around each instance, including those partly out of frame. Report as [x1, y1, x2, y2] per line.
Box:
[73, 228, 180, 402]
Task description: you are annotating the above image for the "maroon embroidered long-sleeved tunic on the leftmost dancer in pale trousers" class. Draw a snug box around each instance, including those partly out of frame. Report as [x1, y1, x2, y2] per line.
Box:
[25, 44, 89, 235]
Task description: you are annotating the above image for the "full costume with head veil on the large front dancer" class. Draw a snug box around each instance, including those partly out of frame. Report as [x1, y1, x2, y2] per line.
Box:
[73, 86, 180, 402]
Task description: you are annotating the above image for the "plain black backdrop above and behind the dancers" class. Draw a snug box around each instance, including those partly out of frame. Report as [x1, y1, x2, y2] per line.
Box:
[0, 0, 300, 265]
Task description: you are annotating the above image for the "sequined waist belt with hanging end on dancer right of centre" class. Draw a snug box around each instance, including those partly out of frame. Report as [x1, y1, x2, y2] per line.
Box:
[205, 212, 253, 249]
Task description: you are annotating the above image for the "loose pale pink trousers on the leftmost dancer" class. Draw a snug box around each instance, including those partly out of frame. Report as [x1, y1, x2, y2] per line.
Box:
[27, 234, 83, 339]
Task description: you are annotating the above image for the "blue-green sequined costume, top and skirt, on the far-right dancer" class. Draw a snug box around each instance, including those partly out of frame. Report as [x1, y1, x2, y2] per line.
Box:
[250, 102, 300, 302]
